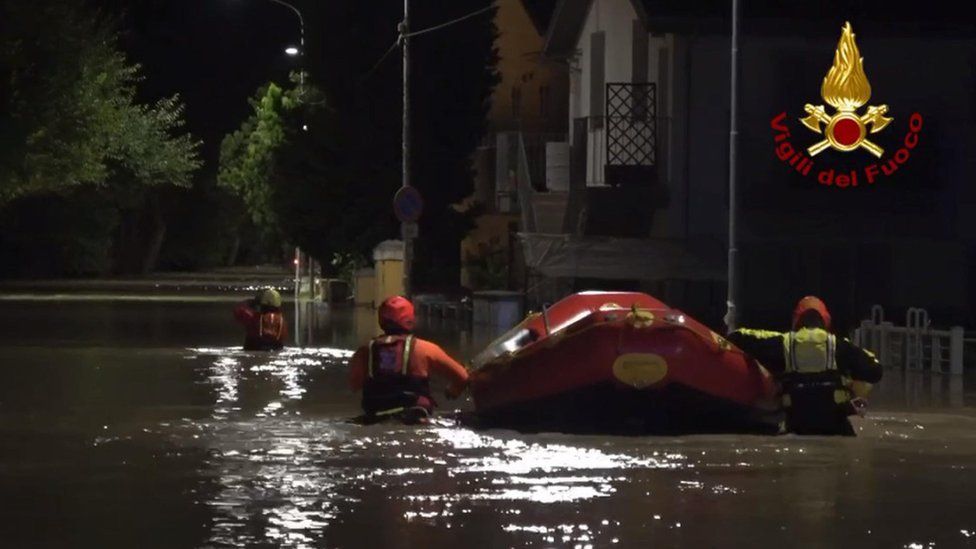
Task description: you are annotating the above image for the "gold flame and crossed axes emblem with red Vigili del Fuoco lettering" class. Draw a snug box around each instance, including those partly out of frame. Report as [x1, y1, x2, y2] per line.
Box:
[770, 23, 922, 189]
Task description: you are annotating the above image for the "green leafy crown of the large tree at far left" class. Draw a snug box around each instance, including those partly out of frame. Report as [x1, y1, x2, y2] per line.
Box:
[0, 0, 200, 204]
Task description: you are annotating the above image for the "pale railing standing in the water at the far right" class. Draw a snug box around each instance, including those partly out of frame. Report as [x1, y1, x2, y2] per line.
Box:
[854, 305, 965, 374]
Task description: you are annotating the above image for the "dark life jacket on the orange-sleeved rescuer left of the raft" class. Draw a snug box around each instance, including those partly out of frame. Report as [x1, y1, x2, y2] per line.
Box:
[363, 335, 433, 414]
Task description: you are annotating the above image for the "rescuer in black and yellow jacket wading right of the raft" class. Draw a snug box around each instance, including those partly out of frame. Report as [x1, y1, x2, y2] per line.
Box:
[728, 296, 882, 436]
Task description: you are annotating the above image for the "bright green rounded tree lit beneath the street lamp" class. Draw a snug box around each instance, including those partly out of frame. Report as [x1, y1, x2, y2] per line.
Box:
[218, 76, 374, 265]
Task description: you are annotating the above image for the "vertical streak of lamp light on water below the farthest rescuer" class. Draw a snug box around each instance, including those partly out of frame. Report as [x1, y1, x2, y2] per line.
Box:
[190, 348, 351, 547]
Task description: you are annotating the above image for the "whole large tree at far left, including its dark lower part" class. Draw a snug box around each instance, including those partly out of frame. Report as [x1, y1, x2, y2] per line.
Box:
[0, 0, 201, 274]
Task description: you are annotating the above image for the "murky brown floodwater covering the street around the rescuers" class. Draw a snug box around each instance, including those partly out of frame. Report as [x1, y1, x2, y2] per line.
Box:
[0, 300, 976, 547]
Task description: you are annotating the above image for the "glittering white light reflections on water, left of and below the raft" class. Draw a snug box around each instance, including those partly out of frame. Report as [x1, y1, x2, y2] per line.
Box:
[188, 348, 720, 547]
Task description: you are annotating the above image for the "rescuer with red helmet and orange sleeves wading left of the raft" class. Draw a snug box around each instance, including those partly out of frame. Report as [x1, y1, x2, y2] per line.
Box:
[349, 296, 468, 422]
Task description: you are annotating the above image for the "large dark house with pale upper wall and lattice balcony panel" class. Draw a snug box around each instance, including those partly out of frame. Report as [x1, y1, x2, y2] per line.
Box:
[523, 0, 976, 328]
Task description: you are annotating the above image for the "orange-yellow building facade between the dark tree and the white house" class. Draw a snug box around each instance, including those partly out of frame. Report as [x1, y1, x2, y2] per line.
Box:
[461, 0, 569, 290]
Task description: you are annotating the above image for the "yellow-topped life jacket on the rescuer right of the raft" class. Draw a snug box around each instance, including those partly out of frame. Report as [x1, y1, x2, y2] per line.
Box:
[783, 328, 851, 408]
